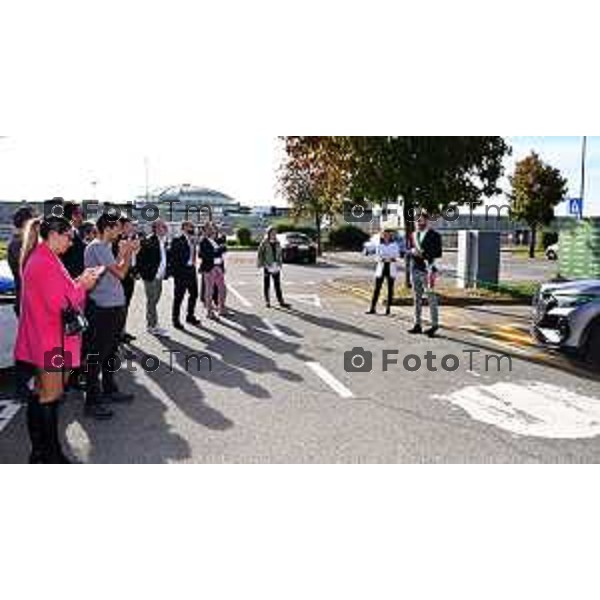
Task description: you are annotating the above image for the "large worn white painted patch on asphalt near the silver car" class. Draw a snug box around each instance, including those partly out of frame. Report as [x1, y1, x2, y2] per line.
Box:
[434, 382, 600, 439]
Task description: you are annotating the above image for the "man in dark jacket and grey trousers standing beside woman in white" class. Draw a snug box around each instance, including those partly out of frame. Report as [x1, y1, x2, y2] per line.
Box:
[409, 211, 442, 338]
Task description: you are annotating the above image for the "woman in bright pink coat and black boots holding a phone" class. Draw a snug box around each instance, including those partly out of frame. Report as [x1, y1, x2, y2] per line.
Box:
[15, 217, 100, 463]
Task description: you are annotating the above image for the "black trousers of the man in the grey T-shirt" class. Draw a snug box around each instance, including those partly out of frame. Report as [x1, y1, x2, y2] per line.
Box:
[84, 301, 126, 403]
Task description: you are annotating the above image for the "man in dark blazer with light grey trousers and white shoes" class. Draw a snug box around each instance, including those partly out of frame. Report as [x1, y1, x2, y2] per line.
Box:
[136, 219, 169, 336]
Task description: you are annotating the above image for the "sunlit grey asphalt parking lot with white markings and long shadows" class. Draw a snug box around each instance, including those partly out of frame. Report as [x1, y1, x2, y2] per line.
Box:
[0, 253, 600, 463]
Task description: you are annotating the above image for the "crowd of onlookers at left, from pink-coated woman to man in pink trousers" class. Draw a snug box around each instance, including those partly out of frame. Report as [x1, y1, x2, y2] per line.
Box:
[8, 202, 244, 463]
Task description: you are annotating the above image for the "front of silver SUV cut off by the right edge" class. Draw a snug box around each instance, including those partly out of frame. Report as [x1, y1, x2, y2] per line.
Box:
[532, 279, 600, 367]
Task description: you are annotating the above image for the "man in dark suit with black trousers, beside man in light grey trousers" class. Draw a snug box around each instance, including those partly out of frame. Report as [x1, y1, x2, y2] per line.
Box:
[170, 221, 200, 329]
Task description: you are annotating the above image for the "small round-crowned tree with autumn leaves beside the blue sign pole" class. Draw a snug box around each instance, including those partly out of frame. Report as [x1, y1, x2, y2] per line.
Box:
[510, 152, 567, 258]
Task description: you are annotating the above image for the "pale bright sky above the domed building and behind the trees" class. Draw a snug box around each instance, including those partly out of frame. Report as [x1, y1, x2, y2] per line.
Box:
[0, 135, 600, 215]
